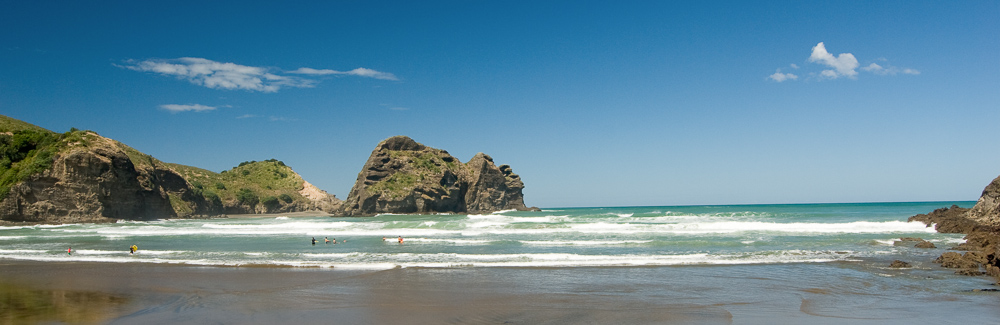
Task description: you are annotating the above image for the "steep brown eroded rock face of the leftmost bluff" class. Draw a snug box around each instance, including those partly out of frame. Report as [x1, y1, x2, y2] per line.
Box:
[0, 134, 177, 223]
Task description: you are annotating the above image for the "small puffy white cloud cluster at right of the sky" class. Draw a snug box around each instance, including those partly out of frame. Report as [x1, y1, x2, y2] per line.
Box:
[767, 42, 920, 82]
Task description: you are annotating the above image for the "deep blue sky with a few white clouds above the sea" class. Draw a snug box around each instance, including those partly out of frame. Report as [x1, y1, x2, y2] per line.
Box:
[0, 1, 1000, 207]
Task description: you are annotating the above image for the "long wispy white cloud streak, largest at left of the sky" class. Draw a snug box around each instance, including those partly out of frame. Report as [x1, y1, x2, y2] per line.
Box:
[115, 57, 399, 93]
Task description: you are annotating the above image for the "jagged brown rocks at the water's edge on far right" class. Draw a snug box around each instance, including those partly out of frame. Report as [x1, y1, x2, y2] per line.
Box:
[908, 177, 1000, 281]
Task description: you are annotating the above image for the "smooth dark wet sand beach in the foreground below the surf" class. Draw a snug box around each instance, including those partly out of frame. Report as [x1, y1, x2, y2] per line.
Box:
[0, 260, 1000, 324]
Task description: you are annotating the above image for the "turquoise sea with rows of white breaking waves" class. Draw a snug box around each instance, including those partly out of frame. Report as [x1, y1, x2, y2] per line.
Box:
[0, 202, 974, 270]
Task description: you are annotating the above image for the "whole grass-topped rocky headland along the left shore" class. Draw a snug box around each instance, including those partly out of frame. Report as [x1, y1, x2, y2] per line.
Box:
[0, 116, 340, 223]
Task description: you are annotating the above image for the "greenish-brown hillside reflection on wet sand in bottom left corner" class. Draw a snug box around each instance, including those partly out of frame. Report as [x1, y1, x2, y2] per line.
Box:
[0, 282, 128, 324]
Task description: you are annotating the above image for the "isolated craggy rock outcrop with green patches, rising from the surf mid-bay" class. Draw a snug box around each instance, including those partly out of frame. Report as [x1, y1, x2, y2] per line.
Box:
[336, 136, 537, 216]
